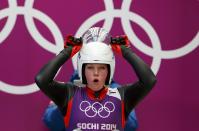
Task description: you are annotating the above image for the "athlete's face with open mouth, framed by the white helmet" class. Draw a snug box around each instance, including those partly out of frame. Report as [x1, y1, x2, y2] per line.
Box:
[85, 64, 108, 91]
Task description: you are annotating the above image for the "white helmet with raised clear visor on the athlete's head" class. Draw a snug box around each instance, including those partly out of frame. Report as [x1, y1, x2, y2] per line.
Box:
[77, 27, 115, 85]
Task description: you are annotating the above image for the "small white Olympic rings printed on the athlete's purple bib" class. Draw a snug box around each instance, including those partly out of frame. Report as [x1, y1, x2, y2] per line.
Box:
[79, 101, 115, 118]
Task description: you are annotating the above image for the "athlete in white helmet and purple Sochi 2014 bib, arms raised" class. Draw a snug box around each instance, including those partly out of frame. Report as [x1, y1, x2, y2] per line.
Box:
[35, 27, 156, 131]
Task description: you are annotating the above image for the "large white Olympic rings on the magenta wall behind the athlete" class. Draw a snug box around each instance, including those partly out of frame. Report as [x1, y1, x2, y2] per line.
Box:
[0, 0, 199, 95]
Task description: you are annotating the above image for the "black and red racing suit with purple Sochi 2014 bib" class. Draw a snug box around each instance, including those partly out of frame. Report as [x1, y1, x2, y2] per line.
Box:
[35, 47, 156, 131]
